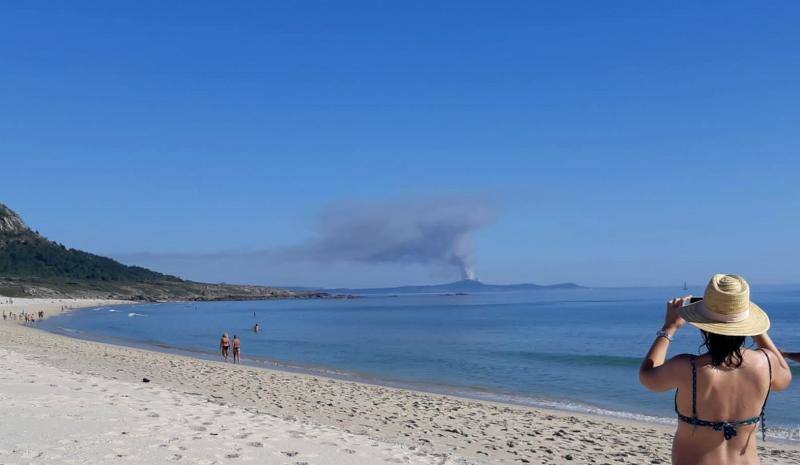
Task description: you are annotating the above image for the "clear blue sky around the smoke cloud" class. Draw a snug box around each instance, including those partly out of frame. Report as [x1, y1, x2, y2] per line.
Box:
[0, 1, 800, 286]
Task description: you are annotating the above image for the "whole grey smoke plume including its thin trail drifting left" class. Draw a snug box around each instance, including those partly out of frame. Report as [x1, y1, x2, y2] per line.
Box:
[111, 197, 497, 284]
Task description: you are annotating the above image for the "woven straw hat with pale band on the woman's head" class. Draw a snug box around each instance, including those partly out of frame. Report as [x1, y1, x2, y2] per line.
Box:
[678, 274, 770, 336]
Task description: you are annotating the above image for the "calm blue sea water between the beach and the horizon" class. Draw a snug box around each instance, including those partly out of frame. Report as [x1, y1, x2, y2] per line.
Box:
[42, 286, 800, 440]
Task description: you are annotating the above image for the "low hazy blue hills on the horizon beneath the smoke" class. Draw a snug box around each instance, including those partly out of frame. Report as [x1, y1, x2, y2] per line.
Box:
[326, 279, 584, 295]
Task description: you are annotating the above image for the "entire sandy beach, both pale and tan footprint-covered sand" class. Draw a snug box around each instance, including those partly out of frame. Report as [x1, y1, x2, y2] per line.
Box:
[0, 299, 800, 464]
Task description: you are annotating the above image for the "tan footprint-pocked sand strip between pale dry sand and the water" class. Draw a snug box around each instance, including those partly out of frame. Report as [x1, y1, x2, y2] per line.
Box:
[0, 304, 800, 464]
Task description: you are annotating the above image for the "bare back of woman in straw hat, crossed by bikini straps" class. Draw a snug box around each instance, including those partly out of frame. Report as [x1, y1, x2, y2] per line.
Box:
[672, 350, 773, 465]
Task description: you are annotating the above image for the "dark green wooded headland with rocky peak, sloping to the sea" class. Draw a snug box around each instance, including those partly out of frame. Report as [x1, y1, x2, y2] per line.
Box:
[0, 203, 332, 301]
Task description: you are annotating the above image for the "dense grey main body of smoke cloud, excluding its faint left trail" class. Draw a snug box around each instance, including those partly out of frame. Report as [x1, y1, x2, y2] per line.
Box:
[289, 198, 497, 279]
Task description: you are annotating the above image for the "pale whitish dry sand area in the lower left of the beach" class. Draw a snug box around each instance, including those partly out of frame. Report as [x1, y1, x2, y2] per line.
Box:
[0, 349, 454, 465]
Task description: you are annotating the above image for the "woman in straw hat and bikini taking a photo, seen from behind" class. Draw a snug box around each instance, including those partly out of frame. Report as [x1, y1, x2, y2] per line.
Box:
[639, 274, 792, 465]
